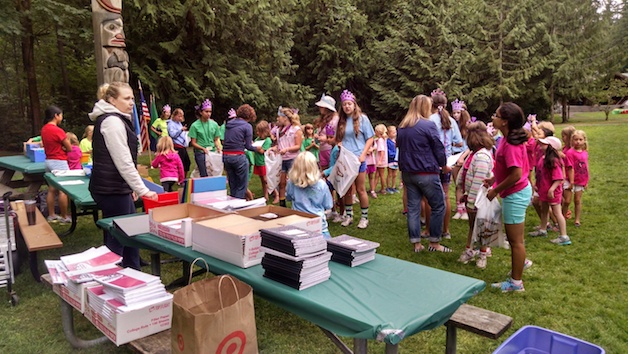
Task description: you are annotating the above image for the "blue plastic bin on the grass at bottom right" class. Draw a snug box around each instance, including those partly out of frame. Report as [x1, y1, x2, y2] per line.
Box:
[493, 326, 605, 354]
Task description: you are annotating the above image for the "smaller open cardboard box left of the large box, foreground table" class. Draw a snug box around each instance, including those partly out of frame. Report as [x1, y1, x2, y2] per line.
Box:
[148, 203, 228, 247]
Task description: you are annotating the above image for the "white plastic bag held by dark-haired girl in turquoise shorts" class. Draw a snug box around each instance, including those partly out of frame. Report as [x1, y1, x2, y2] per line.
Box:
[473, 186, 510, 248]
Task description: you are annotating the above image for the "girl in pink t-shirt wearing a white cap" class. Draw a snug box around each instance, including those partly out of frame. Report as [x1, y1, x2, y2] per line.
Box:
[529, 136, 571, 246]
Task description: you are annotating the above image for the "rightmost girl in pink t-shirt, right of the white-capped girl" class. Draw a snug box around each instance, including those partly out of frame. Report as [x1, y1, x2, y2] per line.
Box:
[563, 130, 589, 226]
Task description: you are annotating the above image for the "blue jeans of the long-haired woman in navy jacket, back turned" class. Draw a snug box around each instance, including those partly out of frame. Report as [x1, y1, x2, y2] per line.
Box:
[401, 172, 445, 243]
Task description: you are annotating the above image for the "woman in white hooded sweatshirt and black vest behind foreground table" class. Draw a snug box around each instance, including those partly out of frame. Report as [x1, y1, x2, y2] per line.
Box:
[89, 82, 157, 269]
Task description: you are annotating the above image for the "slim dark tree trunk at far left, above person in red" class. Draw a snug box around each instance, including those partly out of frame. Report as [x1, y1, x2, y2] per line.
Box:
[17, 0, 42, 132]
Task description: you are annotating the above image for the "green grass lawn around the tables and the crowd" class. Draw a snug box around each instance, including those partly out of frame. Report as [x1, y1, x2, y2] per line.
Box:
[0, 113, 628, 354]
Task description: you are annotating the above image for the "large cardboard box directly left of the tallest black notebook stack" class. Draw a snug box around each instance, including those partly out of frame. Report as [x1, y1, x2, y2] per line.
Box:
[192, 215, 279, 268]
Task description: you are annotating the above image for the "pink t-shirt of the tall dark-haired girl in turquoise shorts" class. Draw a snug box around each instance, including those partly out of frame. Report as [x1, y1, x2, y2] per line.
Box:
[493, 138, 530, 198]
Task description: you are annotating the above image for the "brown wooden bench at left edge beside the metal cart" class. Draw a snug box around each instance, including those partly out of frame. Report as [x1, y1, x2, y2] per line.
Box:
[11, 202, 63, 282]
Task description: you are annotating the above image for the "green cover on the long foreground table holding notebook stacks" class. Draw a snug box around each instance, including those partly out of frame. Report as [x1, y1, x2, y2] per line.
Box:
[98, 218, 486, 345]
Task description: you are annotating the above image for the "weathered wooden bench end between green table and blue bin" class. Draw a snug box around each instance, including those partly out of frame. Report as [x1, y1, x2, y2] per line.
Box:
[445, 304, 512, 354]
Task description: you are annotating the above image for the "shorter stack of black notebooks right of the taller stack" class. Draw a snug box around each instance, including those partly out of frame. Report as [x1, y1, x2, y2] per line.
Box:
[327, 235, 379, 267]
